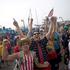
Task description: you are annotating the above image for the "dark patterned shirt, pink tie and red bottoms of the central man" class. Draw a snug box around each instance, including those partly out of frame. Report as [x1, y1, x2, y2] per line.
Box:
[30, 37, 51, 70]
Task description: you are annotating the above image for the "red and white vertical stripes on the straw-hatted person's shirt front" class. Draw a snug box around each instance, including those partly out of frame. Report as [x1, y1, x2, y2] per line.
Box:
[20, 54, 33, 70]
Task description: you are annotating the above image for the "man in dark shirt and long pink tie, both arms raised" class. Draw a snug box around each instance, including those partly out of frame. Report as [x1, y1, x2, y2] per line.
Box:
[28, 18, 53, 70]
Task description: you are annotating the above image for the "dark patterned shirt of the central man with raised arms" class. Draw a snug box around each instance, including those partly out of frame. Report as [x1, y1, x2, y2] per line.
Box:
[30, 37, 48, 63]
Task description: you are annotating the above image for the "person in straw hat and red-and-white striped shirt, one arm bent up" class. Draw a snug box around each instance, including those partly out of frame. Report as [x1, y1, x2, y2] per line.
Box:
[2, 37, 35, 70]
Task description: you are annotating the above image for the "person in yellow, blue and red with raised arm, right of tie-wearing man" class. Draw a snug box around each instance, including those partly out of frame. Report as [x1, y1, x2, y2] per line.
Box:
[47, 17, 61, 70]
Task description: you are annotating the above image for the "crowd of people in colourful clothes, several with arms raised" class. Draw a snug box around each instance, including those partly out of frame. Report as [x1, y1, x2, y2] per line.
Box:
[0, 16, 70, 70]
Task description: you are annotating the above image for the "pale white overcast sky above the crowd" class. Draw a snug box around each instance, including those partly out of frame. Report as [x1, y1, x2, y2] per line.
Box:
[0, 0, 70, 29]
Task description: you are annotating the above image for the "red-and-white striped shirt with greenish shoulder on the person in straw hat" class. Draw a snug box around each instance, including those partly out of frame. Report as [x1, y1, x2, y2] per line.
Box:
[19, 52, 33, 70]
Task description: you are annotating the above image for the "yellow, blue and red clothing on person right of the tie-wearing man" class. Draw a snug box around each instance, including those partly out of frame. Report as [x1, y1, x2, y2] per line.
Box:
[47, 32, 60, 60]
